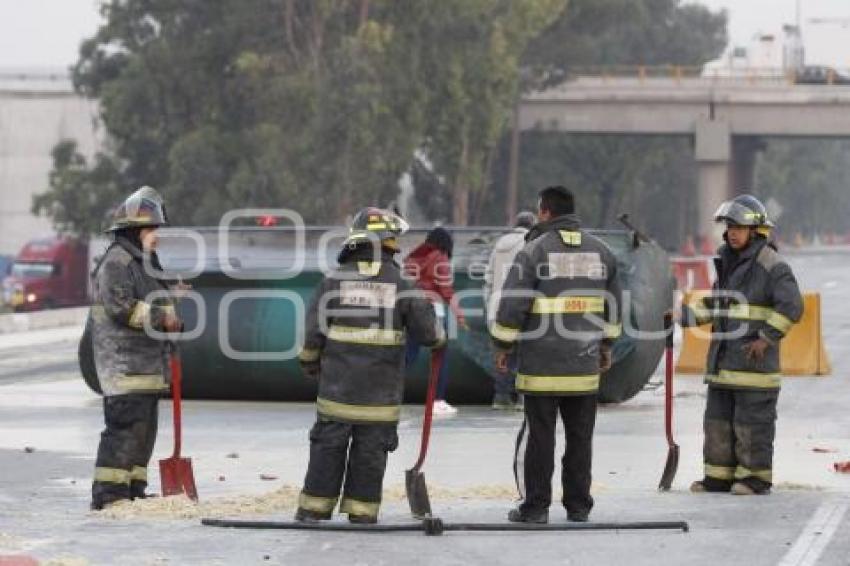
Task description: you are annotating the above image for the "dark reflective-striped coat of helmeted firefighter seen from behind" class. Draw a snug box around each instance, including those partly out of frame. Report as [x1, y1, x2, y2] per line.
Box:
[299, 247, 445, 423]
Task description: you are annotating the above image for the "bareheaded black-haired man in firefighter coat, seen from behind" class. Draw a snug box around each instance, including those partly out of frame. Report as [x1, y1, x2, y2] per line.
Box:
[490, 186, 621, 523]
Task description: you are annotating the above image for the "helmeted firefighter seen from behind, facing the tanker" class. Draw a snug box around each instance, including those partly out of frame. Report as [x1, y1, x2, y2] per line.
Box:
[295, 208, 445, 523]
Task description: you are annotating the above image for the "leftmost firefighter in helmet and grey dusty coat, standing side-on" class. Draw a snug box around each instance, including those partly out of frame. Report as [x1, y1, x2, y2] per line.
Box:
[88, 187, 182, 510]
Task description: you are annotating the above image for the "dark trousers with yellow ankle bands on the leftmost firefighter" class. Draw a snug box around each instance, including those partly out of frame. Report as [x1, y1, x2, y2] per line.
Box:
[92, 394, 159, 506]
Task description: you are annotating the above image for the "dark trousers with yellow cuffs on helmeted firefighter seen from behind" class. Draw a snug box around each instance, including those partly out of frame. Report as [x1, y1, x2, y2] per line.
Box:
[298, 418, 398, 518]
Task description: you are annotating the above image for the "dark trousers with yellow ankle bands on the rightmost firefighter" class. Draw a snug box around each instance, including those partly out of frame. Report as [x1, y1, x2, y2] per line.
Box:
[703, 387, 779, 492]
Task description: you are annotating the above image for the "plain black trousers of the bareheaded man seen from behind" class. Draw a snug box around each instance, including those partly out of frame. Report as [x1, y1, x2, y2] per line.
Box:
[520, 395, 596, 515]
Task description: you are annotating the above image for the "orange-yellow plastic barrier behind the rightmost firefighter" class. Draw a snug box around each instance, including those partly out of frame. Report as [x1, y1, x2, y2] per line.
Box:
[676, 293, 832, 375]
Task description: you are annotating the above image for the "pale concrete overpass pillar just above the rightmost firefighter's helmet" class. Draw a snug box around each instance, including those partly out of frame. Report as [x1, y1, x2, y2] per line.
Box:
[694, 118, 733, 243]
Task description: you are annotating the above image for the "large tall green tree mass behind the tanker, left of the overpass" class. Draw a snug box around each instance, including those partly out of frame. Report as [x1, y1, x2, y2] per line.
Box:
[38, 0, 566, 233]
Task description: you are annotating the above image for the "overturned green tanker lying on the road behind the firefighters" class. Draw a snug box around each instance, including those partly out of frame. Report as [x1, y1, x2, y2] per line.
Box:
[80, 227, 674, 403]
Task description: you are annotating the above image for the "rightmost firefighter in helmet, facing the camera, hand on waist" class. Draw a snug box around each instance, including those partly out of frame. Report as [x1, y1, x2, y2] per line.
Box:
[681, 195, 803, 495]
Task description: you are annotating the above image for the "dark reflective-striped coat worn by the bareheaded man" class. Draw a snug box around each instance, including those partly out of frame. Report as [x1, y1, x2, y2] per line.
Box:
[490, 215, 621, 396]
